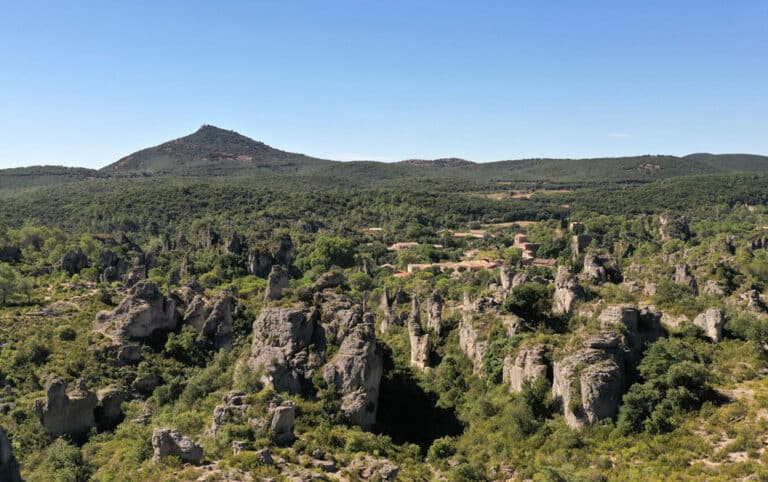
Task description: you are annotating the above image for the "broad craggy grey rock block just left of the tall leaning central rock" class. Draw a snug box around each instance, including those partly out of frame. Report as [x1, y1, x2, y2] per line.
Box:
[248, 303, 319, 394]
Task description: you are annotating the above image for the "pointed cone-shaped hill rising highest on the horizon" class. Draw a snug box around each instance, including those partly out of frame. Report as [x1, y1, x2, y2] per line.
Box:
[101, 125, 333, 176]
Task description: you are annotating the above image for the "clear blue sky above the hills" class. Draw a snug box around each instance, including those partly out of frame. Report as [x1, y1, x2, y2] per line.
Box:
[0, 0, 768, 167]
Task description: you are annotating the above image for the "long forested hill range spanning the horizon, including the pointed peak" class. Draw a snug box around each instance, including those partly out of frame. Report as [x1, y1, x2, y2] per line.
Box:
[0, 125, 768, 189]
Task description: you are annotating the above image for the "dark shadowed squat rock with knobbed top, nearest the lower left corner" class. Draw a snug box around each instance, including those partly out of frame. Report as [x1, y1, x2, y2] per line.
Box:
[35, 378, 99, 441]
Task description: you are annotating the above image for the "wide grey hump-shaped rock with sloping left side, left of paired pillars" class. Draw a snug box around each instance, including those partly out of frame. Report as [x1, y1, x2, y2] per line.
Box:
[95, 281, 176, 342]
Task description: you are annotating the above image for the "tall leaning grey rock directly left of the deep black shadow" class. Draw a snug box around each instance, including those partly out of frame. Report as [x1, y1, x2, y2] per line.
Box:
[323, 314, 384, 428]
